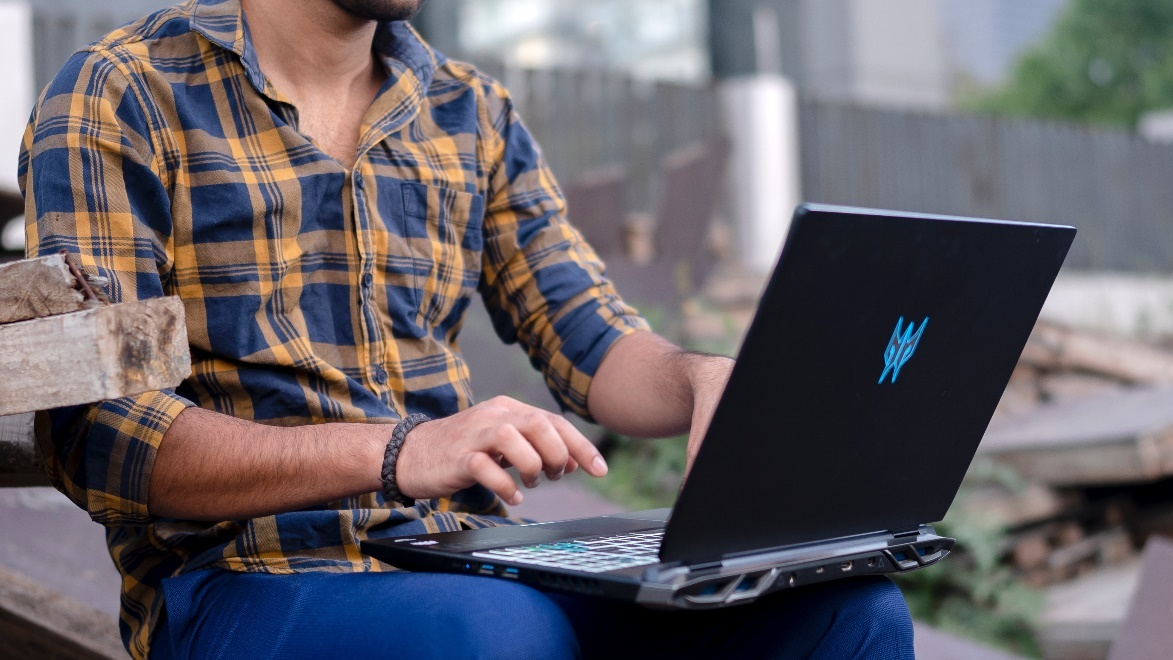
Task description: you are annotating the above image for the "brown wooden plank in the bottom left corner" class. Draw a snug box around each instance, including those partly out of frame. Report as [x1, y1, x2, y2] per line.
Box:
[0, 569, 127, 660]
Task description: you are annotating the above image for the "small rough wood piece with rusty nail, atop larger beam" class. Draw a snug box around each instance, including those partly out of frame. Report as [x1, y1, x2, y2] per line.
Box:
[0, 254, 86, 324]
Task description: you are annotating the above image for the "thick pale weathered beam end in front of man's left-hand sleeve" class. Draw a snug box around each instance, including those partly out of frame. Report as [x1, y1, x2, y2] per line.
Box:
[0, 298, 191, 415]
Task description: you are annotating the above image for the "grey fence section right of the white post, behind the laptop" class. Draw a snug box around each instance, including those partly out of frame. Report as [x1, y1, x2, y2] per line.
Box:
[800, 100, 1173, 272]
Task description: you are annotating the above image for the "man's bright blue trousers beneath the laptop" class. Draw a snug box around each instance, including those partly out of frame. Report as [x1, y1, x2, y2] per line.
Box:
[151, 570, 913, 660]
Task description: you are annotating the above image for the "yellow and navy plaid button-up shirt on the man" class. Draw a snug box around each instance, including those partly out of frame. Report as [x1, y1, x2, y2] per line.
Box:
[19, 0, 646, 658]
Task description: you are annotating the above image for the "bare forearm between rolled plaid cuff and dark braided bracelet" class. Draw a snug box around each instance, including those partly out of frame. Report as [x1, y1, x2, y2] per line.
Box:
[148, 408, 391, 520]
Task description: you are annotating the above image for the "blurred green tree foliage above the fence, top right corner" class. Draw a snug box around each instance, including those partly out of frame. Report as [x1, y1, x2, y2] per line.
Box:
[963, 0, 1173, 128]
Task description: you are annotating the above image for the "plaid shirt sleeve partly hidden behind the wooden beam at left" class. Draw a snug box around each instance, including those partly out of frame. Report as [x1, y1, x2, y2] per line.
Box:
[19, 53, 191, 525]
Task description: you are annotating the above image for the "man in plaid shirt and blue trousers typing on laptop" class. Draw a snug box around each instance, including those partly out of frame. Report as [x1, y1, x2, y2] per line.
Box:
[20, 0, 911, 658]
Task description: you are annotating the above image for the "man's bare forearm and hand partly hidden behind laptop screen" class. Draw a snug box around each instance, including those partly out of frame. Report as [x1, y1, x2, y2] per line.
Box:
[587, 332, 733, 437]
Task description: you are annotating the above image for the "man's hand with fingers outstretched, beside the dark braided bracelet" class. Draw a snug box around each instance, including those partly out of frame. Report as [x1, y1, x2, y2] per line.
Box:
[395, 396, 606, 505]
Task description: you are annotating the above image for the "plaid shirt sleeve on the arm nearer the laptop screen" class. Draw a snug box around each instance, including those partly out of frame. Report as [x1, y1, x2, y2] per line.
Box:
[481, 76, 649, 420]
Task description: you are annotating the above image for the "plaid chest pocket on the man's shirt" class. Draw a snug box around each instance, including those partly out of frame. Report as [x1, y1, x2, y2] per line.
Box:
[402, 183, 484, 331]
